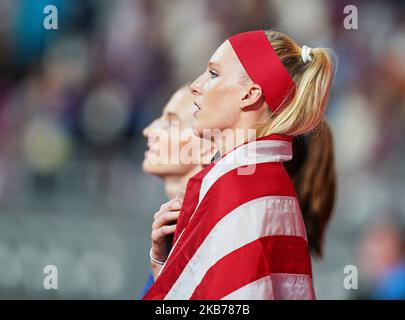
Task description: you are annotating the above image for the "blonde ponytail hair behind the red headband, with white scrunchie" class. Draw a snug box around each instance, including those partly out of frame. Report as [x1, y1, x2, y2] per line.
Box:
[257, 30, 333, 137]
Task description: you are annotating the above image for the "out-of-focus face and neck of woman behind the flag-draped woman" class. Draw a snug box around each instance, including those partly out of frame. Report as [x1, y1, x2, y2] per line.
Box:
[141, 85, 214, 297]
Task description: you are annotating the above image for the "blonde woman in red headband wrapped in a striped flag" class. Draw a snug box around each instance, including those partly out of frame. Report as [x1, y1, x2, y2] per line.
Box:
[144, 30, 334, 299]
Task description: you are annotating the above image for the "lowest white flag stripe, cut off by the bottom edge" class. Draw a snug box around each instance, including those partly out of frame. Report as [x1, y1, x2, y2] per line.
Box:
[223, 273, 315, 300]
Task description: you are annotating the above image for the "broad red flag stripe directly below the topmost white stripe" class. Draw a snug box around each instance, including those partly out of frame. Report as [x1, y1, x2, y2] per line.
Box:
[144, 162, 296, 299]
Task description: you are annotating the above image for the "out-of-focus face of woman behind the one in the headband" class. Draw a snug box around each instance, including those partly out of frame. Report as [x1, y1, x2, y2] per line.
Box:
[142, 88, 208, 178]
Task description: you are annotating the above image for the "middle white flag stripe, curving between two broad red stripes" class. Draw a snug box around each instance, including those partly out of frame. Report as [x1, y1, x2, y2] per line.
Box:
[165, 196, 306, 299]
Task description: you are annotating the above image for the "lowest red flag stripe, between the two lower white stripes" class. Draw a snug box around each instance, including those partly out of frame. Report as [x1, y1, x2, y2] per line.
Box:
[191, 236, 312, 300]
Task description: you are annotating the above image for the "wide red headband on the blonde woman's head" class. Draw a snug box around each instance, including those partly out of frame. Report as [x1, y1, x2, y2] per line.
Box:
[228, 30, 295, 112]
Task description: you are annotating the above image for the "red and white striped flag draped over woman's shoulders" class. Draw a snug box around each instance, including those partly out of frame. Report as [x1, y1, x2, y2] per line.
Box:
[144, 134, 315, 300]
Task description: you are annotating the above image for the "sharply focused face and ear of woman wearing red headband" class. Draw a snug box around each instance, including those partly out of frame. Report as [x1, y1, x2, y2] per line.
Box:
[190, 40, 263, 137]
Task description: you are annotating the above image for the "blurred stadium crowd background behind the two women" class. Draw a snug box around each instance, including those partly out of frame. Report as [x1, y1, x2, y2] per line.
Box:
[0, 0, 405, 299]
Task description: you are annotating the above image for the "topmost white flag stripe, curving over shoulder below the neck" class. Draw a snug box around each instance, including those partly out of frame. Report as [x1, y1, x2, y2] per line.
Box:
[197, 140, 292, 208]
